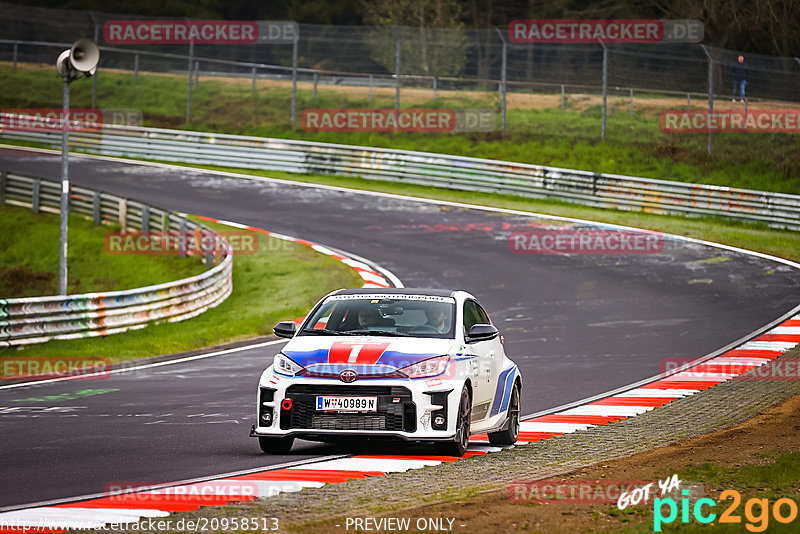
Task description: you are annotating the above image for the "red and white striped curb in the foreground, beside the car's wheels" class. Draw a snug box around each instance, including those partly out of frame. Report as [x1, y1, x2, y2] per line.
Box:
[0, 316, 800, 533]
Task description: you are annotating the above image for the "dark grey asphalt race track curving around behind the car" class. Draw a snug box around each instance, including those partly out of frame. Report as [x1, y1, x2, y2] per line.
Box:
[0, 149, 800, 507]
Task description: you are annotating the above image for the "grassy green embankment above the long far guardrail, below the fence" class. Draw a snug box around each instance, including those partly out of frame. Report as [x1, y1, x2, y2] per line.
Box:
[0, 64, 800, 194]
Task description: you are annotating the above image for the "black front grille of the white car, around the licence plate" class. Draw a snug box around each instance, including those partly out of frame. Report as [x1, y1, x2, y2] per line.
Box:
[280, 384, 417, 432]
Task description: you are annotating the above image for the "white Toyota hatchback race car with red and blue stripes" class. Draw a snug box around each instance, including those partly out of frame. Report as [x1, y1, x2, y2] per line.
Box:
[250, 288, 522, 456]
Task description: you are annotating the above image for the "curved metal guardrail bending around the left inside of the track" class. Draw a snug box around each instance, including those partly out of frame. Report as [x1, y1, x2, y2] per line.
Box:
[0, 171, 233, 347]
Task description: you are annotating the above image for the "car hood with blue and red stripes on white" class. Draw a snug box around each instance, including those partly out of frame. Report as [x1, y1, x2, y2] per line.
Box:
[281, 336, 457, 375]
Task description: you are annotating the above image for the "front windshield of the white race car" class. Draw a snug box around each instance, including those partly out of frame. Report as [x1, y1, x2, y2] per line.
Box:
[300, 295, 455, 339]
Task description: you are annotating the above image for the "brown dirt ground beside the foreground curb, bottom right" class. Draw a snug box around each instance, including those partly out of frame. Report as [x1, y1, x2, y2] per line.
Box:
[303, 396, 800, 534]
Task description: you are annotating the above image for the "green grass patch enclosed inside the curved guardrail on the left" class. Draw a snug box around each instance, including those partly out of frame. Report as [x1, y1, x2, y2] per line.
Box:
[0, 205, 204, 298]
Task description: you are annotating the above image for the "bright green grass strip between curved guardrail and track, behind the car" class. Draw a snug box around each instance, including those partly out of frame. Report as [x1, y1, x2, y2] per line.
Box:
[0, 221, 363, 361]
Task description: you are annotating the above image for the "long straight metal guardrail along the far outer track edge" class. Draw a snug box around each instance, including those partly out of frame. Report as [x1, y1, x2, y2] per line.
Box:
[0, 121, 800, 230]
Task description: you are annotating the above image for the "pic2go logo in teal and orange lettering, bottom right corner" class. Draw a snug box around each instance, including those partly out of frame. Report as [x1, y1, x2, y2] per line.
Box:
[653, 490, 797, 532]
